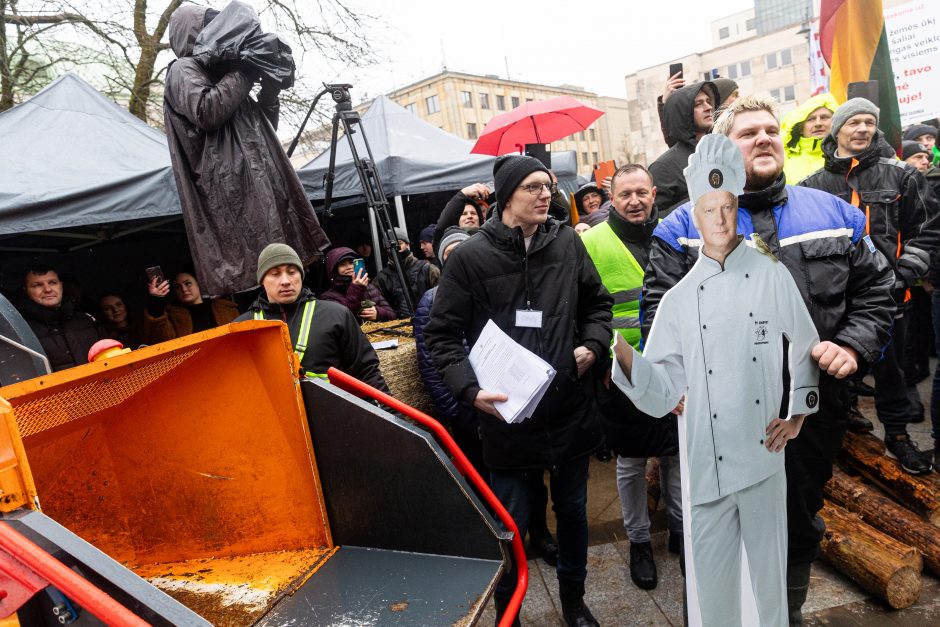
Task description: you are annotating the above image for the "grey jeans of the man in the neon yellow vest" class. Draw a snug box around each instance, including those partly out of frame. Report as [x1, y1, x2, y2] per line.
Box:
[617, 455, 682, 544]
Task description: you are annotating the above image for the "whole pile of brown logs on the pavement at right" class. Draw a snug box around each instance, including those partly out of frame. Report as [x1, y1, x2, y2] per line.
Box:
[820, 433, 940, 609]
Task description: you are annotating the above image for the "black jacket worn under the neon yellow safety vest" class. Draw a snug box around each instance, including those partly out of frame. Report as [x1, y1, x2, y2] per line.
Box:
[598, 207, 679, 457]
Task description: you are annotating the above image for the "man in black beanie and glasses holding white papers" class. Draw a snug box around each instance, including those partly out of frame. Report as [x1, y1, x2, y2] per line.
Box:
[424, 156, 612, 625]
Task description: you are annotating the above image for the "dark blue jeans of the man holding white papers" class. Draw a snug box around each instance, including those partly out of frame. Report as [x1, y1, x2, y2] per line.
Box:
[490, 456, 589, 601]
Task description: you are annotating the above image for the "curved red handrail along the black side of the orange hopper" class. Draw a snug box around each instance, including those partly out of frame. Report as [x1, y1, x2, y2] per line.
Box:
[327, 368, 529, 627]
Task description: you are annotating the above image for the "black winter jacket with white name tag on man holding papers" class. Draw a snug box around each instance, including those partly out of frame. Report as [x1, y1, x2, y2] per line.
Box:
[424, 214, 613, 469]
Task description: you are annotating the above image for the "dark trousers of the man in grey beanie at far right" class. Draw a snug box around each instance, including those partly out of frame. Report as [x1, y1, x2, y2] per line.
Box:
[872, 316, 913, 436]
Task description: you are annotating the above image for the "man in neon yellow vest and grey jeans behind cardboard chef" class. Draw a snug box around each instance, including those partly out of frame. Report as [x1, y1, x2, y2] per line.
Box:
[581, 164, 682, 590]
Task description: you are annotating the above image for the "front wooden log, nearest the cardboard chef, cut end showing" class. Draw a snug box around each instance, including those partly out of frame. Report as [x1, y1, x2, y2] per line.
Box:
[819, 501, 921, 609]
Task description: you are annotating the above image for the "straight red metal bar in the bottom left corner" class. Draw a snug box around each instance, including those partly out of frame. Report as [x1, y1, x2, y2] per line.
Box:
[0, 523, 150, 627]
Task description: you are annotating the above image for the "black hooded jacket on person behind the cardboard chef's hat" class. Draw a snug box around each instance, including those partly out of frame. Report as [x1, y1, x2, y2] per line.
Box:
[649, 81, 719, 217]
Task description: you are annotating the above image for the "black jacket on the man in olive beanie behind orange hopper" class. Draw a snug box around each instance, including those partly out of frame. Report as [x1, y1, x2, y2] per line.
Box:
[235, 287, 388, 392]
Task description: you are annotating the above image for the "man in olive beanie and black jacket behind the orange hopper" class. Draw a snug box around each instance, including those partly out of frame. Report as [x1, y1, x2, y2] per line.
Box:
[235, 244, 388, 392]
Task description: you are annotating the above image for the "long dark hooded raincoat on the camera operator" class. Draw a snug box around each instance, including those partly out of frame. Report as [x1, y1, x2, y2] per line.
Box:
[163, 5, 329, 296]
